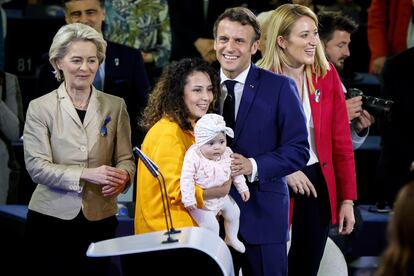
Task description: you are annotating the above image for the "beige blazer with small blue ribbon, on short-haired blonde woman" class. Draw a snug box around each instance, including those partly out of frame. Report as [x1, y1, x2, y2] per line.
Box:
[23, 83, 135, 221]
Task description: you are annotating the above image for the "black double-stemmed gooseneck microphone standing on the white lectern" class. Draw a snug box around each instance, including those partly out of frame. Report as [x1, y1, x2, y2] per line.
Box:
[132, 147, 181, 243]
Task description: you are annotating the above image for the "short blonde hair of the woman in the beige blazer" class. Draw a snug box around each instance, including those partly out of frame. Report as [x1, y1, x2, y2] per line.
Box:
[49, 23, 106, 81]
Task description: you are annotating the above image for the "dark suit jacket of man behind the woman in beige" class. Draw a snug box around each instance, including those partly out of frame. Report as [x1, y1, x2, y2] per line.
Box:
[36, 41, 150, 145]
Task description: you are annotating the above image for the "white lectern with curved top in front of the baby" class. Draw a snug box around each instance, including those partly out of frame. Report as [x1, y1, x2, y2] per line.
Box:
[86, 227, 234, 276]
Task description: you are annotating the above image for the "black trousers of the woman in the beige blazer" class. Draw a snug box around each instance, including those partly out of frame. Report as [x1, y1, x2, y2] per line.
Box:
[21, 210, 118, 276]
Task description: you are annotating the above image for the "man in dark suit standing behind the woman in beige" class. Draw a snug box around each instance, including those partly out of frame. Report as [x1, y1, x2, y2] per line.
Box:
[37, 0, 150, 146]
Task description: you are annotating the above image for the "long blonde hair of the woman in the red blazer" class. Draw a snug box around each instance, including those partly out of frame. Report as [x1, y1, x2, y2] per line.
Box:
[257, 4, 329, 93]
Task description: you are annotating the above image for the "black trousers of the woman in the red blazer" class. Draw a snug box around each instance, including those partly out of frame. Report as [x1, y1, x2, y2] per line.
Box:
[288, 163, 331, 276]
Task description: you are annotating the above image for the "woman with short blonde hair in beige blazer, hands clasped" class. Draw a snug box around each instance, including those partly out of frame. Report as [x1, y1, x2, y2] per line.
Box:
[23, 23, 135, 275]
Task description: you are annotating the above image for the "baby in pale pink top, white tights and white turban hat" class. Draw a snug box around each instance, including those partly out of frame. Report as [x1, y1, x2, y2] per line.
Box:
[180, 114, 250, 253]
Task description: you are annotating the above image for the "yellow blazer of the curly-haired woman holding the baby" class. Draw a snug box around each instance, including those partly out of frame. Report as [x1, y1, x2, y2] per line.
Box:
[135, 118, 203, 234]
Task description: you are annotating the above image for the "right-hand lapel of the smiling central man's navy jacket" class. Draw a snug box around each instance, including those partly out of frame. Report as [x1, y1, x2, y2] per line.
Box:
[234, 64, 259, 141]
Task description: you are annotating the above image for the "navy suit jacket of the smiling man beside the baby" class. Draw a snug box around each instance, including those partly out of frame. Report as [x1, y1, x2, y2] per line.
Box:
[230, 64, 309, 244]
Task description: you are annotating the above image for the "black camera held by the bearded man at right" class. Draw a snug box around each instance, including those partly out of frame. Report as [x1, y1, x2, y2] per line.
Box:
[346, 88, 394, 118]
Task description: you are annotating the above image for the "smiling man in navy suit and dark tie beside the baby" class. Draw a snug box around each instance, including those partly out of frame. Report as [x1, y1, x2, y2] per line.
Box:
[213, 7, 309, 276]
